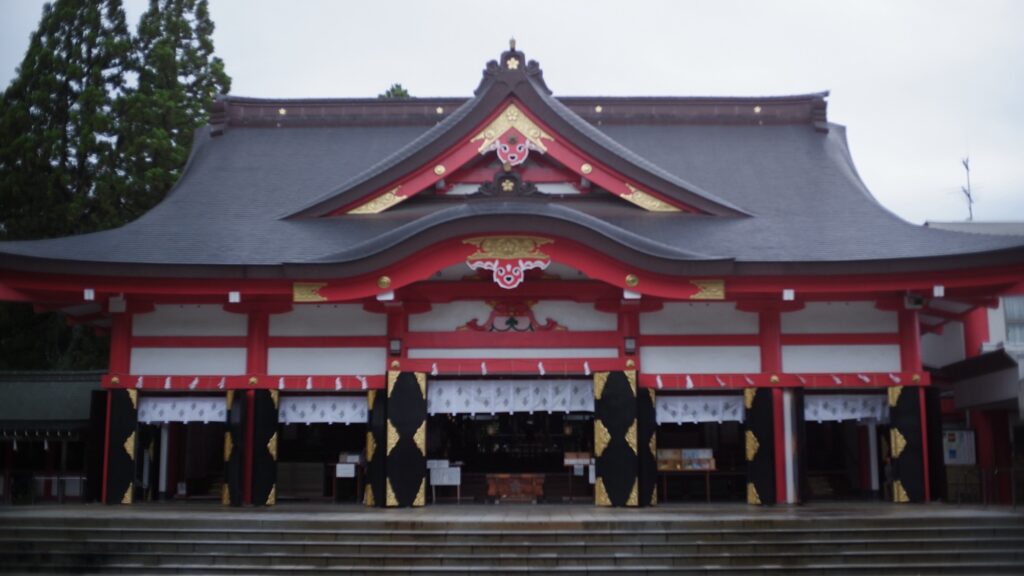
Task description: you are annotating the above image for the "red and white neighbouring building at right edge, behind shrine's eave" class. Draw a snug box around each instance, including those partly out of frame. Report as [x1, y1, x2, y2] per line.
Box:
[922, 221, 1024, 502]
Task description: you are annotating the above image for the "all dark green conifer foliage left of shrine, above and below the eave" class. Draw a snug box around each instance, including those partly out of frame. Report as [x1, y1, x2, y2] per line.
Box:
[0, 0, 230, 369]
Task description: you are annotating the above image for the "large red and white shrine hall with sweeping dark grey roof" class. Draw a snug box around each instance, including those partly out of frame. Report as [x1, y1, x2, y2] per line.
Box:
[6, 47, 1024, 506]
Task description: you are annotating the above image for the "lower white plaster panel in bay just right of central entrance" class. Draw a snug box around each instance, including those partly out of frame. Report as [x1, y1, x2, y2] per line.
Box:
[640, 346, 761, 374]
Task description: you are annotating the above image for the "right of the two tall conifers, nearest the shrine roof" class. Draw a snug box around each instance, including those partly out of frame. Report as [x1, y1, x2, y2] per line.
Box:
[118, 0, 231, 217]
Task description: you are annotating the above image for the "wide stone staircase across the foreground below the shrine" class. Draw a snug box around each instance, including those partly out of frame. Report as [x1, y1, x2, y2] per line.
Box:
[0, 505, 1024, 575]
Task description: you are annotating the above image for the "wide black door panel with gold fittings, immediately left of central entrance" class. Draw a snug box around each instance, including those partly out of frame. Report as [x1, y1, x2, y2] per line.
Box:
[382, 372, 427, 507]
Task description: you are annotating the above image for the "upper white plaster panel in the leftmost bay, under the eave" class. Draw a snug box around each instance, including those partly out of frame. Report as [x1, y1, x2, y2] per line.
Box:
[132, 304, 249, 336]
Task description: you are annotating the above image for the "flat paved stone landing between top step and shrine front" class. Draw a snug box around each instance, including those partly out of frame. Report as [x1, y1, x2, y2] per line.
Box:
[0, 502, 1024, 524]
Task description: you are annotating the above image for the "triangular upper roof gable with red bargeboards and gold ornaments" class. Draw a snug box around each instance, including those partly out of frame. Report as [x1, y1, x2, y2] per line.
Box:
[292, 47, 745, 217]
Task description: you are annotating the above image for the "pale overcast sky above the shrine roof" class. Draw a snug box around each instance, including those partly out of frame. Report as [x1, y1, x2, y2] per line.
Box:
[0, 0, 1024, 222]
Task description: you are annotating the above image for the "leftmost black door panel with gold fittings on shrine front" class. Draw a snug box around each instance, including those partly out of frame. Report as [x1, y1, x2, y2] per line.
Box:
[103, 389, 138, 504]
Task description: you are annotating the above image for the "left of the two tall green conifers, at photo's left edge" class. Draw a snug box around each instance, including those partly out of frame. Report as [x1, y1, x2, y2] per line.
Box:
[0, 0, 131, 240]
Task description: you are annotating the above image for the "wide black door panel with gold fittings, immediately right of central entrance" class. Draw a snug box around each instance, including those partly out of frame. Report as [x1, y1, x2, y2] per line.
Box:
[594, 371, 634, 506]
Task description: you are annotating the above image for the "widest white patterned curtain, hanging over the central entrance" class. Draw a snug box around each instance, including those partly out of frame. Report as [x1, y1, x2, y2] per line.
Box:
[427, 380, 594, 414]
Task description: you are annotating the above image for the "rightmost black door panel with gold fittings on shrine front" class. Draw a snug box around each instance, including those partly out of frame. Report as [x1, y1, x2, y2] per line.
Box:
[889, 386, 928, 502]
